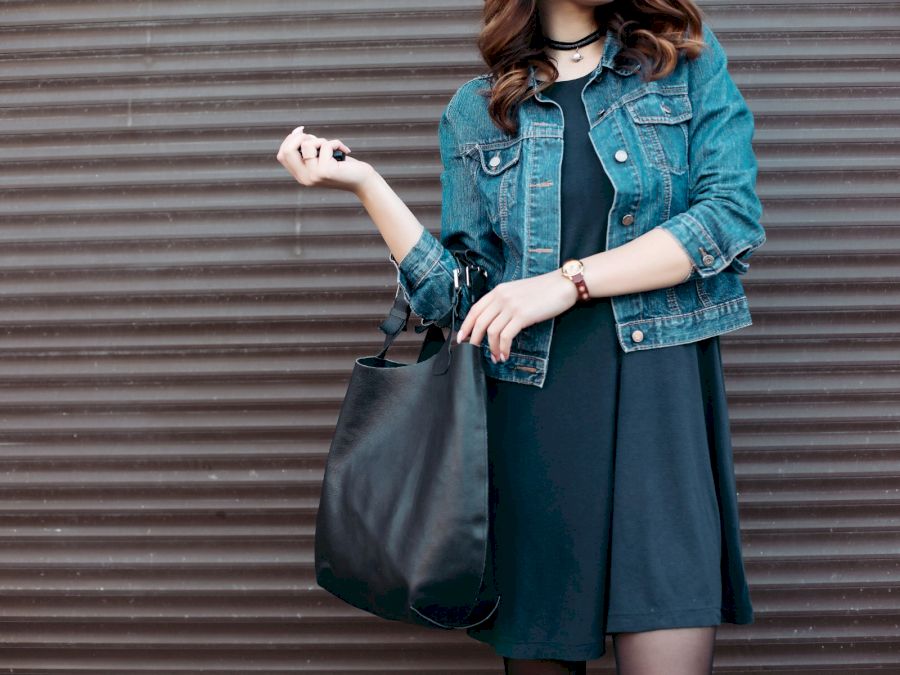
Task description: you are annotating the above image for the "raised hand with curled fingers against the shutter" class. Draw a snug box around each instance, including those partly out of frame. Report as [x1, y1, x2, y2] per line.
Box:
[275, 126, 375, 192]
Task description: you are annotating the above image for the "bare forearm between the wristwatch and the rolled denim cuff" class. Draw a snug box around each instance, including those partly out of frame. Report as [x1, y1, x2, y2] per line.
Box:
[580, 228, 691, 297]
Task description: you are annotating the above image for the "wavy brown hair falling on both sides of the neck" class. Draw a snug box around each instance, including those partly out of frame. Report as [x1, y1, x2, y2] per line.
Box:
[478, 0, 704, 134]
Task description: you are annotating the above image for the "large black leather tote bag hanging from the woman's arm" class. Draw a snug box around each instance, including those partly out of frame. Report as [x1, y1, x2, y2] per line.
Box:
[315, 258, 500, 629]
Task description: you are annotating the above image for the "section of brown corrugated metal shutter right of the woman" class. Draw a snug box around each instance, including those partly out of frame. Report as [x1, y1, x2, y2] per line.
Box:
[710, 2, 900, 675]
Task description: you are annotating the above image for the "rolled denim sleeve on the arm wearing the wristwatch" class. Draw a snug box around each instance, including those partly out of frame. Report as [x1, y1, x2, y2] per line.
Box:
[657, 25, 766, 278]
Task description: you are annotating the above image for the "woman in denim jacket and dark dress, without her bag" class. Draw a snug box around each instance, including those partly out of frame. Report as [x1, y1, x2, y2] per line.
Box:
[278, 0, 765, 675]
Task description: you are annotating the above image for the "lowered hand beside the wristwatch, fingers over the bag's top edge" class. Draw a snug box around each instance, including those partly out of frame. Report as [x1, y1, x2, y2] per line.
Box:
[457, 269, 578, 363]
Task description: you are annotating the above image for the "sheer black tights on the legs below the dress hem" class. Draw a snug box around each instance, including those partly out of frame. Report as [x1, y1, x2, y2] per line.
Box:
[503, 626, 716, 675]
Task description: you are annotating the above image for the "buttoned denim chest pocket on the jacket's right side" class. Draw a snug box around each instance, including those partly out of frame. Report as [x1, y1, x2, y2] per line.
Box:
[625, 91, 693, 174]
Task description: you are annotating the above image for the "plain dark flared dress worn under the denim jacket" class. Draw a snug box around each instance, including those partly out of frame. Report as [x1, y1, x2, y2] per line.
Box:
[467, 75, 752, 660]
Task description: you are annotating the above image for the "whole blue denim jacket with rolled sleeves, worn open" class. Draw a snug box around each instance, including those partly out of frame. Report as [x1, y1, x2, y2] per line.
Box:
[389, 25, 765, 387]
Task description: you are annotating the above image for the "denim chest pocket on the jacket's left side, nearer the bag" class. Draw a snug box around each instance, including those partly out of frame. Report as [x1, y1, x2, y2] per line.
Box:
[470, 139, 522, 262]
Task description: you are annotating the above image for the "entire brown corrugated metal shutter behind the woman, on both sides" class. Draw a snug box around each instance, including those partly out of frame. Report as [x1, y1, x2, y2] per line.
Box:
[0, 0, 900, 675]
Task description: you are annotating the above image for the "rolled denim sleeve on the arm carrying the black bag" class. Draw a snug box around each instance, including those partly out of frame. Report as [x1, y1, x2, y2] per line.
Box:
[389, 95, 502, 327]
